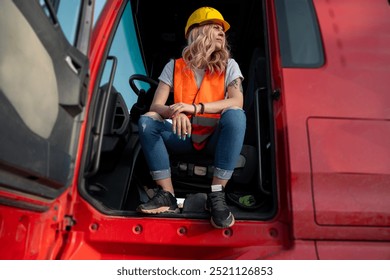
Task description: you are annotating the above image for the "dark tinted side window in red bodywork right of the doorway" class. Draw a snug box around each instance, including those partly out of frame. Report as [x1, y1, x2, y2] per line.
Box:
[275, 0, 324, 68]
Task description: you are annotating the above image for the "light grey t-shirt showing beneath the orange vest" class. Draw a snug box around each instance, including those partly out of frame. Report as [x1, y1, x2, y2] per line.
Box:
[158, 58, 244, 94]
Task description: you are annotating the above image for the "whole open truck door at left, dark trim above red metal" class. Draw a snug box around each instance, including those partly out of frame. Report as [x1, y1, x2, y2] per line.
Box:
[0, 0, 94, 259]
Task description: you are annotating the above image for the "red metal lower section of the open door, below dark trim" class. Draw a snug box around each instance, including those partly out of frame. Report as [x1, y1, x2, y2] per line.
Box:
[0, 193, 67, 260]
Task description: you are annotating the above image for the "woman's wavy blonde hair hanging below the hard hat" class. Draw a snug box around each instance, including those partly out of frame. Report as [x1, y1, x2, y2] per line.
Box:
[182, 24, 230, 73]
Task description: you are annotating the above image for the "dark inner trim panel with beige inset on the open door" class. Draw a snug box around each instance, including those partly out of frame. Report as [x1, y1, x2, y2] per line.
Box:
[0, 0, 88, 198]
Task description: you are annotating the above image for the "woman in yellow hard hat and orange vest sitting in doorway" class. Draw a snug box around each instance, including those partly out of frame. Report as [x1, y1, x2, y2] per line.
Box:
[137, 7, 246, 228]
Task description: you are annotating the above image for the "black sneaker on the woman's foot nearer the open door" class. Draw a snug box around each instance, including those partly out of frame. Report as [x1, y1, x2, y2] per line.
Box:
[137, 188, 180, 214]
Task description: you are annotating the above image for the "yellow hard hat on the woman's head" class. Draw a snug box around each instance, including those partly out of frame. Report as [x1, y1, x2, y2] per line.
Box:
[184, 7, 230, 38]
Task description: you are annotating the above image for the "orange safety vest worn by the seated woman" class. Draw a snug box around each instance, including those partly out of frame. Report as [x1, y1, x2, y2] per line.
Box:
[173, 58, 225, 150]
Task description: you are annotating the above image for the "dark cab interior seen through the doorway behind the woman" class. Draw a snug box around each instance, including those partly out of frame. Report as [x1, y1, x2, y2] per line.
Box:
[81, 0, 276, 220]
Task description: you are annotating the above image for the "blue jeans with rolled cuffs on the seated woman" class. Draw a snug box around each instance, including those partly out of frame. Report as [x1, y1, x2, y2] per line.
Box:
[138, 109, 246, 180]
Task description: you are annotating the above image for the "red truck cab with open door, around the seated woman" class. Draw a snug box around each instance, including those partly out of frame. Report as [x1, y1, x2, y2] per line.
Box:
[0, 0, 390, 259]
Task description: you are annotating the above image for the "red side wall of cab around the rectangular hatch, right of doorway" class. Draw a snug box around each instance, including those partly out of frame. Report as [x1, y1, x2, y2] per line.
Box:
[282, 0, 390, 240]
